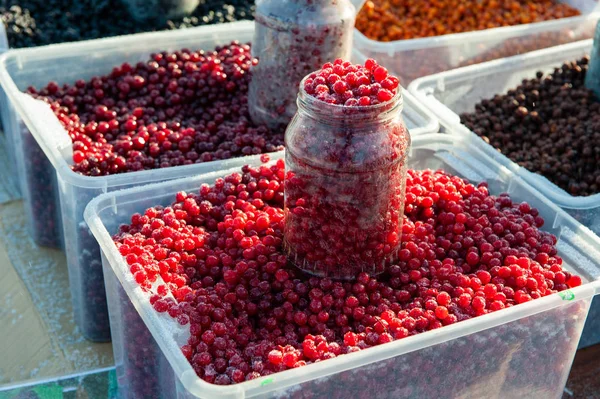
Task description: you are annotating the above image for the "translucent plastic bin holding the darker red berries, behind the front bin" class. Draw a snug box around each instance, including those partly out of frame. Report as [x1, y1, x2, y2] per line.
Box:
[0, 22, 438, 341]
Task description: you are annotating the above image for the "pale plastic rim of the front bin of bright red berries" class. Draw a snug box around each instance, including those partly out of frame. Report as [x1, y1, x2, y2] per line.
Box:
[84, 134, 600, 398]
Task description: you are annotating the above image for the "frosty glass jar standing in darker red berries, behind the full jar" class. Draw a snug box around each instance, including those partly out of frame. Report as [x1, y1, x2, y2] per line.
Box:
[248, 0, 356, 128]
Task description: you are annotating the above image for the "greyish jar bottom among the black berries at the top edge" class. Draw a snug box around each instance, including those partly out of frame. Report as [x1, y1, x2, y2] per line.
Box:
[121, 0, 200, 22]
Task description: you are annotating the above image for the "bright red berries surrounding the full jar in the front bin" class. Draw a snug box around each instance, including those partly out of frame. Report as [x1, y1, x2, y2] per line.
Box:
[114, 156, 581, 385]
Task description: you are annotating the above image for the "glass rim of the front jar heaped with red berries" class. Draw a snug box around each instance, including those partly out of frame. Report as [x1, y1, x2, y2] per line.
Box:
[297, 74, 404, 119]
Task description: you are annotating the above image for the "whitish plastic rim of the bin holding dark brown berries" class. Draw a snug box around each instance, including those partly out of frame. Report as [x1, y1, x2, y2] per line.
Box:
[408, 39, 600, 209]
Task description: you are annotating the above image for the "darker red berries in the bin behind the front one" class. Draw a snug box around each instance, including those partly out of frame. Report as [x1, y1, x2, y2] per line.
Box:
[28, 42, 283, 176]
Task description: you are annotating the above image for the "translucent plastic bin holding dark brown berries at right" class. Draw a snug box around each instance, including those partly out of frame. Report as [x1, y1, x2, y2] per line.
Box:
[409, 40, 600, 345]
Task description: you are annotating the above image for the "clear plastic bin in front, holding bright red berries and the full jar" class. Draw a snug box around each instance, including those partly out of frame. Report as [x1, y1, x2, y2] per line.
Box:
[85, 134, 600, 399]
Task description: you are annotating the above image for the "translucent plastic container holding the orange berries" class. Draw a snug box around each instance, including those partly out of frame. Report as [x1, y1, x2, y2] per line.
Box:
[354, 0, 600, 86]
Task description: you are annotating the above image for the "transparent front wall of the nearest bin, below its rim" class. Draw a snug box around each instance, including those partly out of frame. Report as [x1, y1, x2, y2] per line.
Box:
[255, 299, 590, 399]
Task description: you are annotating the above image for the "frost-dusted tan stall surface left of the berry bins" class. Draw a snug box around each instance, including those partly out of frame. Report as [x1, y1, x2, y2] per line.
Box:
[0, 135, 113, 390]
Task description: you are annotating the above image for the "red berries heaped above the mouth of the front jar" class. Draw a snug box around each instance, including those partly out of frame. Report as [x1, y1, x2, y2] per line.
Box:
[304, 59, 400, 107]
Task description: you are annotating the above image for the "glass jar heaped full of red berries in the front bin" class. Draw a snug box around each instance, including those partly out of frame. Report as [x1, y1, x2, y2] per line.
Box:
[284, 59, 410, 279]
